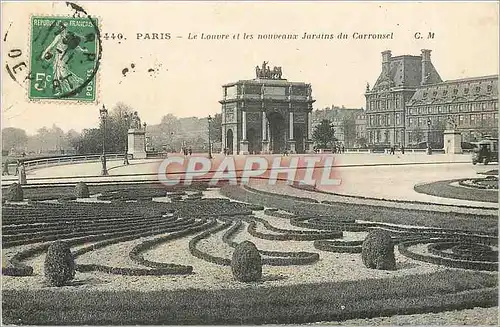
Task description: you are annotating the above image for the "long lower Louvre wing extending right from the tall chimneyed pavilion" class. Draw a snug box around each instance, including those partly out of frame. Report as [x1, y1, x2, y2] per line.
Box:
[406, 75, 498, 144]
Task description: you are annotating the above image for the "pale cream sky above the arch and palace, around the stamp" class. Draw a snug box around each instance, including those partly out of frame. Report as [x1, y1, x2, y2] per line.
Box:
[2, 1, 499, 134]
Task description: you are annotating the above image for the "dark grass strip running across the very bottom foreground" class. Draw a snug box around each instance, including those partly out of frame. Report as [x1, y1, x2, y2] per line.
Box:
[2, 270, 498, 325]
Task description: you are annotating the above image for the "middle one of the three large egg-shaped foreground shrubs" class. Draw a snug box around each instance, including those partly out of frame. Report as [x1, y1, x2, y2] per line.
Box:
[231, 241, 262, 282]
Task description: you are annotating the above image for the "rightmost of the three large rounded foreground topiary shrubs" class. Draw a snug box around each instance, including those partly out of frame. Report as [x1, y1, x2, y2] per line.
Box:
[361, 229, 396, 270]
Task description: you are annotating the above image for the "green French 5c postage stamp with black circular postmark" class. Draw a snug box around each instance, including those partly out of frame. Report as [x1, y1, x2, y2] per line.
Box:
[29, 16, 100, 102]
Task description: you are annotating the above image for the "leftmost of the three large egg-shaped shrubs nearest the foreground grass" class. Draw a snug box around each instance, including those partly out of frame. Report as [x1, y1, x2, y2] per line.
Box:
[44, 241, 75, 286]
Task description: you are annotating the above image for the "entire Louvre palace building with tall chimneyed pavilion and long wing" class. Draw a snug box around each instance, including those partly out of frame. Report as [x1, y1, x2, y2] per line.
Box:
[365, 49, 498, 146]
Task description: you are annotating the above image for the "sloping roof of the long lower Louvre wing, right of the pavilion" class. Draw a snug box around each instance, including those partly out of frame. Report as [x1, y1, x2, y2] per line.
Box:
[408, 75, 498, 105]
